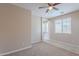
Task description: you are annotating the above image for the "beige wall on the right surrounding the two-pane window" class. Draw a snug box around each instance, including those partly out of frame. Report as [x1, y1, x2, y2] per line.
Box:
[50, 11, 79, 45]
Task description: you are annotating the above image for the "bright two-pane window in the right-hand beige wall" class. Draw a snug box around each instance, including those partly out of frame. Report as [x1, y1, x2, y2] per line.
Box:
[55, 17, 71, 33]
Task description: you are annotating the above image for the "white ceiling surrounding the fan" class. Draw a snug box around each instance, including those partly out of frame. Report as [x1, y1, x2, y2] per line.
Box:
[14, 3, 79, 18]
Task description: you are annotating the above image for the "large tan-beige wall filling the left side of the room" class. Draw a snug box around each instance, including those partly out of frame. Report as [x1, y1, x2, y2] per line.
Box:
[0, 4, 31, 54]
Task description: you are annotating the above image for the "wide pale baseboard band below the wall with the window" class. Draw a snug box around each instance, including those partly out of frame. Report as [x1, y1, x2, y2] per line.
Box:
[44, 40, 79, 54]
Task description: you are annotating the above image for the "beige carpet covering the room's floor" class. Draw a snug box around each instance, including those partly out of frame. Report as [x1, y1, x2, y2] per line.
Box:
[6, 42, 78, 56]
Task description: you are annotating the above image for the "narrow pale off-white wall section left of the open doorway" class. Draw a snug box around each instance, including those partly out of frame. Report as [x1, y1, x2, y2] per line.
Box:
[31, 15, 41, 43]
